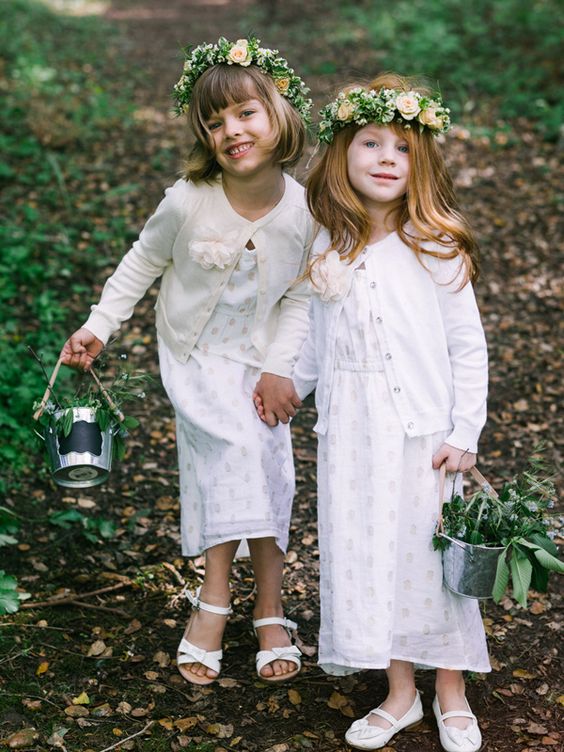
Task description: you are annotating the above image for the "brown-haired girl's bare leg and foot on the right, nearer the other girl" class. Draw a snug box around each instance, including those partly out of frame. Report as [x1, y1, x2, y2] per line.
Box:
[248, 538, 296, 676]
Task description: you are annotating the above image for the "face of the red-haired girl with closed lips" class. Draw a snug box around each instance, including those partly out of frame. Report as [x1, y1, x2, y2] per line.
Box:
[347, 125, 409, 210]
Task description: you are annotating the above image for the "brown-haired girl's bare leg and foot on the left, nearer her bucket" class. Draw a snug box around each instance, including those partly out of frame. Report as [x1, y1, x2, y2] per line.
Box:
[180, 541, 239, 679]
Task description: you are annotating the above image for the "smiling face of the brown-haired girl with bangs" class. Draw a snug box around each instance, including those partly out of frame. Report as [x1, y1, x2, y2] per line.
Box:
[206, 98, 273, 178]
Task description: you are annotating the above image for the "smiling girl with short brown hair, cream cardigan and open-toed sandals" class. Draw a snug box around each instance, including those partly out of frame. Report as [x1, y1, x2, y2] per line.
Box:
[62, 38, 318, 684]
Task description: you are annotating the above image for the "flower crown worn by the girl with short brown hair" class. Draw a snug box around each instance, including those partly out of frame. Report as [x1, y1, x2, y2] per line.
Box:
[173, 37, 312, 125]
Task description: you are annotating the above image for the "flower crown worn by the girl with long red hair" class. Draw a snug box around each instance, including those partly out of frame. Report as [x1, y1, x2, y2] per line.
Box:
[318, 86, 450, 144]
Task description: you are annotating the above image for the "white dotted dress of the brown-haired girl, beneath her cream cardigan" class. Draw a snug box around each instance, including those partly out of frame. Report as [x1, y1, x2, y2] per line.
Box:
[159, 244, 295, 556]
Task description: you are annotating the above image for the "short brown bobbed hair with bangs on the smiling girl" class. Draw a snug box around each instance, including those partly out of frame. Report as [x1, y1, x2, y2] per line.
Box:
[185, 63, 306, 182]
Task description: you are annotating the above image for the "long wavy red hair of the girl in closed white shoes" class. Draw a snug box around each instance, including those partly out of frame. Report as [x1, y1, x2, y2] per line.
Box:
[307, 73, 479, 285]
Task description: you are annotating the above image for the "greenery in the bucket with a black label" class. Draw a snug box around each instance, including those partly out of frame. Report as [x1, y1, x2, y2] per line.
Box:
[34, 355, 151, 460]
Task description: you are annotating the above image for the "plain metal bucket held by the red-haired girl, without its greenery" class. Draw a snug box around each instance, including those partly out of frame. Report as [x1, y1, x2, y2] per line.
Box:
[441, 533, 505, 598]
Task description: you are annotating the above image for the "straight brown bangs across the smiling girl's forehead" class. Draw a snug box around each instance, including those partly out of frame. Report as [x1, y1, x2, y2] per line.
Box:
[198, 64, 257, 120]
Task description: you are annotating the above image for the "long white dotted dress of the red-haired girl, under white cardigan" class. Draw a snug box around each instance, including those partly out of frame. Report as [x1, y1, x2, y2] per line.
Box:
[318, 264, 490, 675]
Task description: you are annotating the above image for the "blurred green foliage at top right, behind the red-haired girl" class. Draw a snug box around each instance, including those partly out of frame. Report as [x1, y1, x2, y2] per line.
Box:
[341, 0, 564, 138]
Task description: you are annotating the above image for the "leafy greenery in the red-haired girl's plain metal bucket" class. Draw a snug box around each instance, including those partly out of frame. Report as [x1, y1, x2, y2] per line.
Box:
[433, 454, 564, 606]
